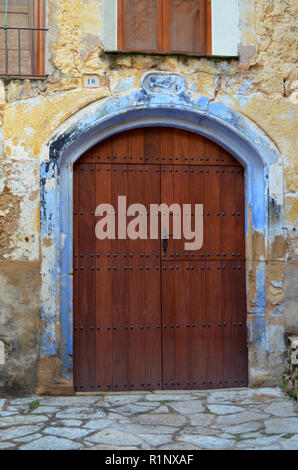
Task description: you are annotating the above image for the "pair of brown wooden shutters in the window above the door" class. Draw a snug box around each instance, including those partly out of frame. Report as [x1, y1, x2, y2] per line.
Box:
[118, 0, 211, 54]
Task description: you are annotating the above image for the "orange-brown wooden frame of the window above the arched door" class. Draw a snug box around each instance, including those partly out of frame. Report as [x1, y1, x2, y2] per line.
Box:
[117, 0, 212, 55]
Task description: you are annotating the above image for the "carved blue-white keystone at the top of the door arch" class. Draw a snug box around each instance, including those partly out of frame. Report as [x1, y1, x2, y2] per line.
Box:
[142, 72, 186, 95]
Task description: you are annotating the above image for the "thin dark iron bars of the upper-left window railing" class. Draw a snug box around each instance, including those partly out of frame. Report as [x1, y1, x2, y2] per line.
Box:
[0, 26, 48, 78]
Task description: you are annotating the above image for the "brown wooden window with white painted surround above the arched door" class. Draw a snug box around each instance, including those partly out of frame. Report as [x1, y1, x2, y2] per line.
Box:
[103, 0, 239, 57]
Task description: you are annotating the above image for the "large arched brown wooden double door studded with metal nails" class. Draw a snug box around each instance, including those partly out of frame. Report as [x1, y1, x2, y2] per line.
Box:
[73, 128, 248, 391]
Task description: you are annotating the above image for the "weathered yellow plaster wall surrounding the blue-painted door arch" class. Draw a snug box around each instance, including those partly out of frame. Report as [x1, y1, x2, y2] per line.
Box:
[0, 0, 298, 393]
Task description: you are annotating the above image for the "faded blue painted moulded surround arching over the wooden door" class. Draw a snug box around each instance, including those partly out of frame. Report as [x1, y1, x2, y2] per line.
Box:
[41, 73, 278, 377]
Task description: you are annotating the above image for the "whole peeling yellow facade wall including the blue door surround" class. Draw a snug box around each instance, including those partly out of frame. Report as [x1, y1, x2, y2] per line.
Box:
[0, 0, 298, 393]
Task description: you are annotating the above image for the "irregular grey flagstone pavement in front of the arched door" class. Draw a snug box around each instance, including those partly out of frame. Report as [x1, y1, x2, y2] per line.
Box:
[0, 388, 298, 450]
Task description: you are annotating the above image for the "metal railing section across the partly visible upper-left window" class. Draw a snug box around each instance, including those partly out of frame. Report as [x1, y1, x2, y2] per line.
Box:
[0, 27, 47, 78]
